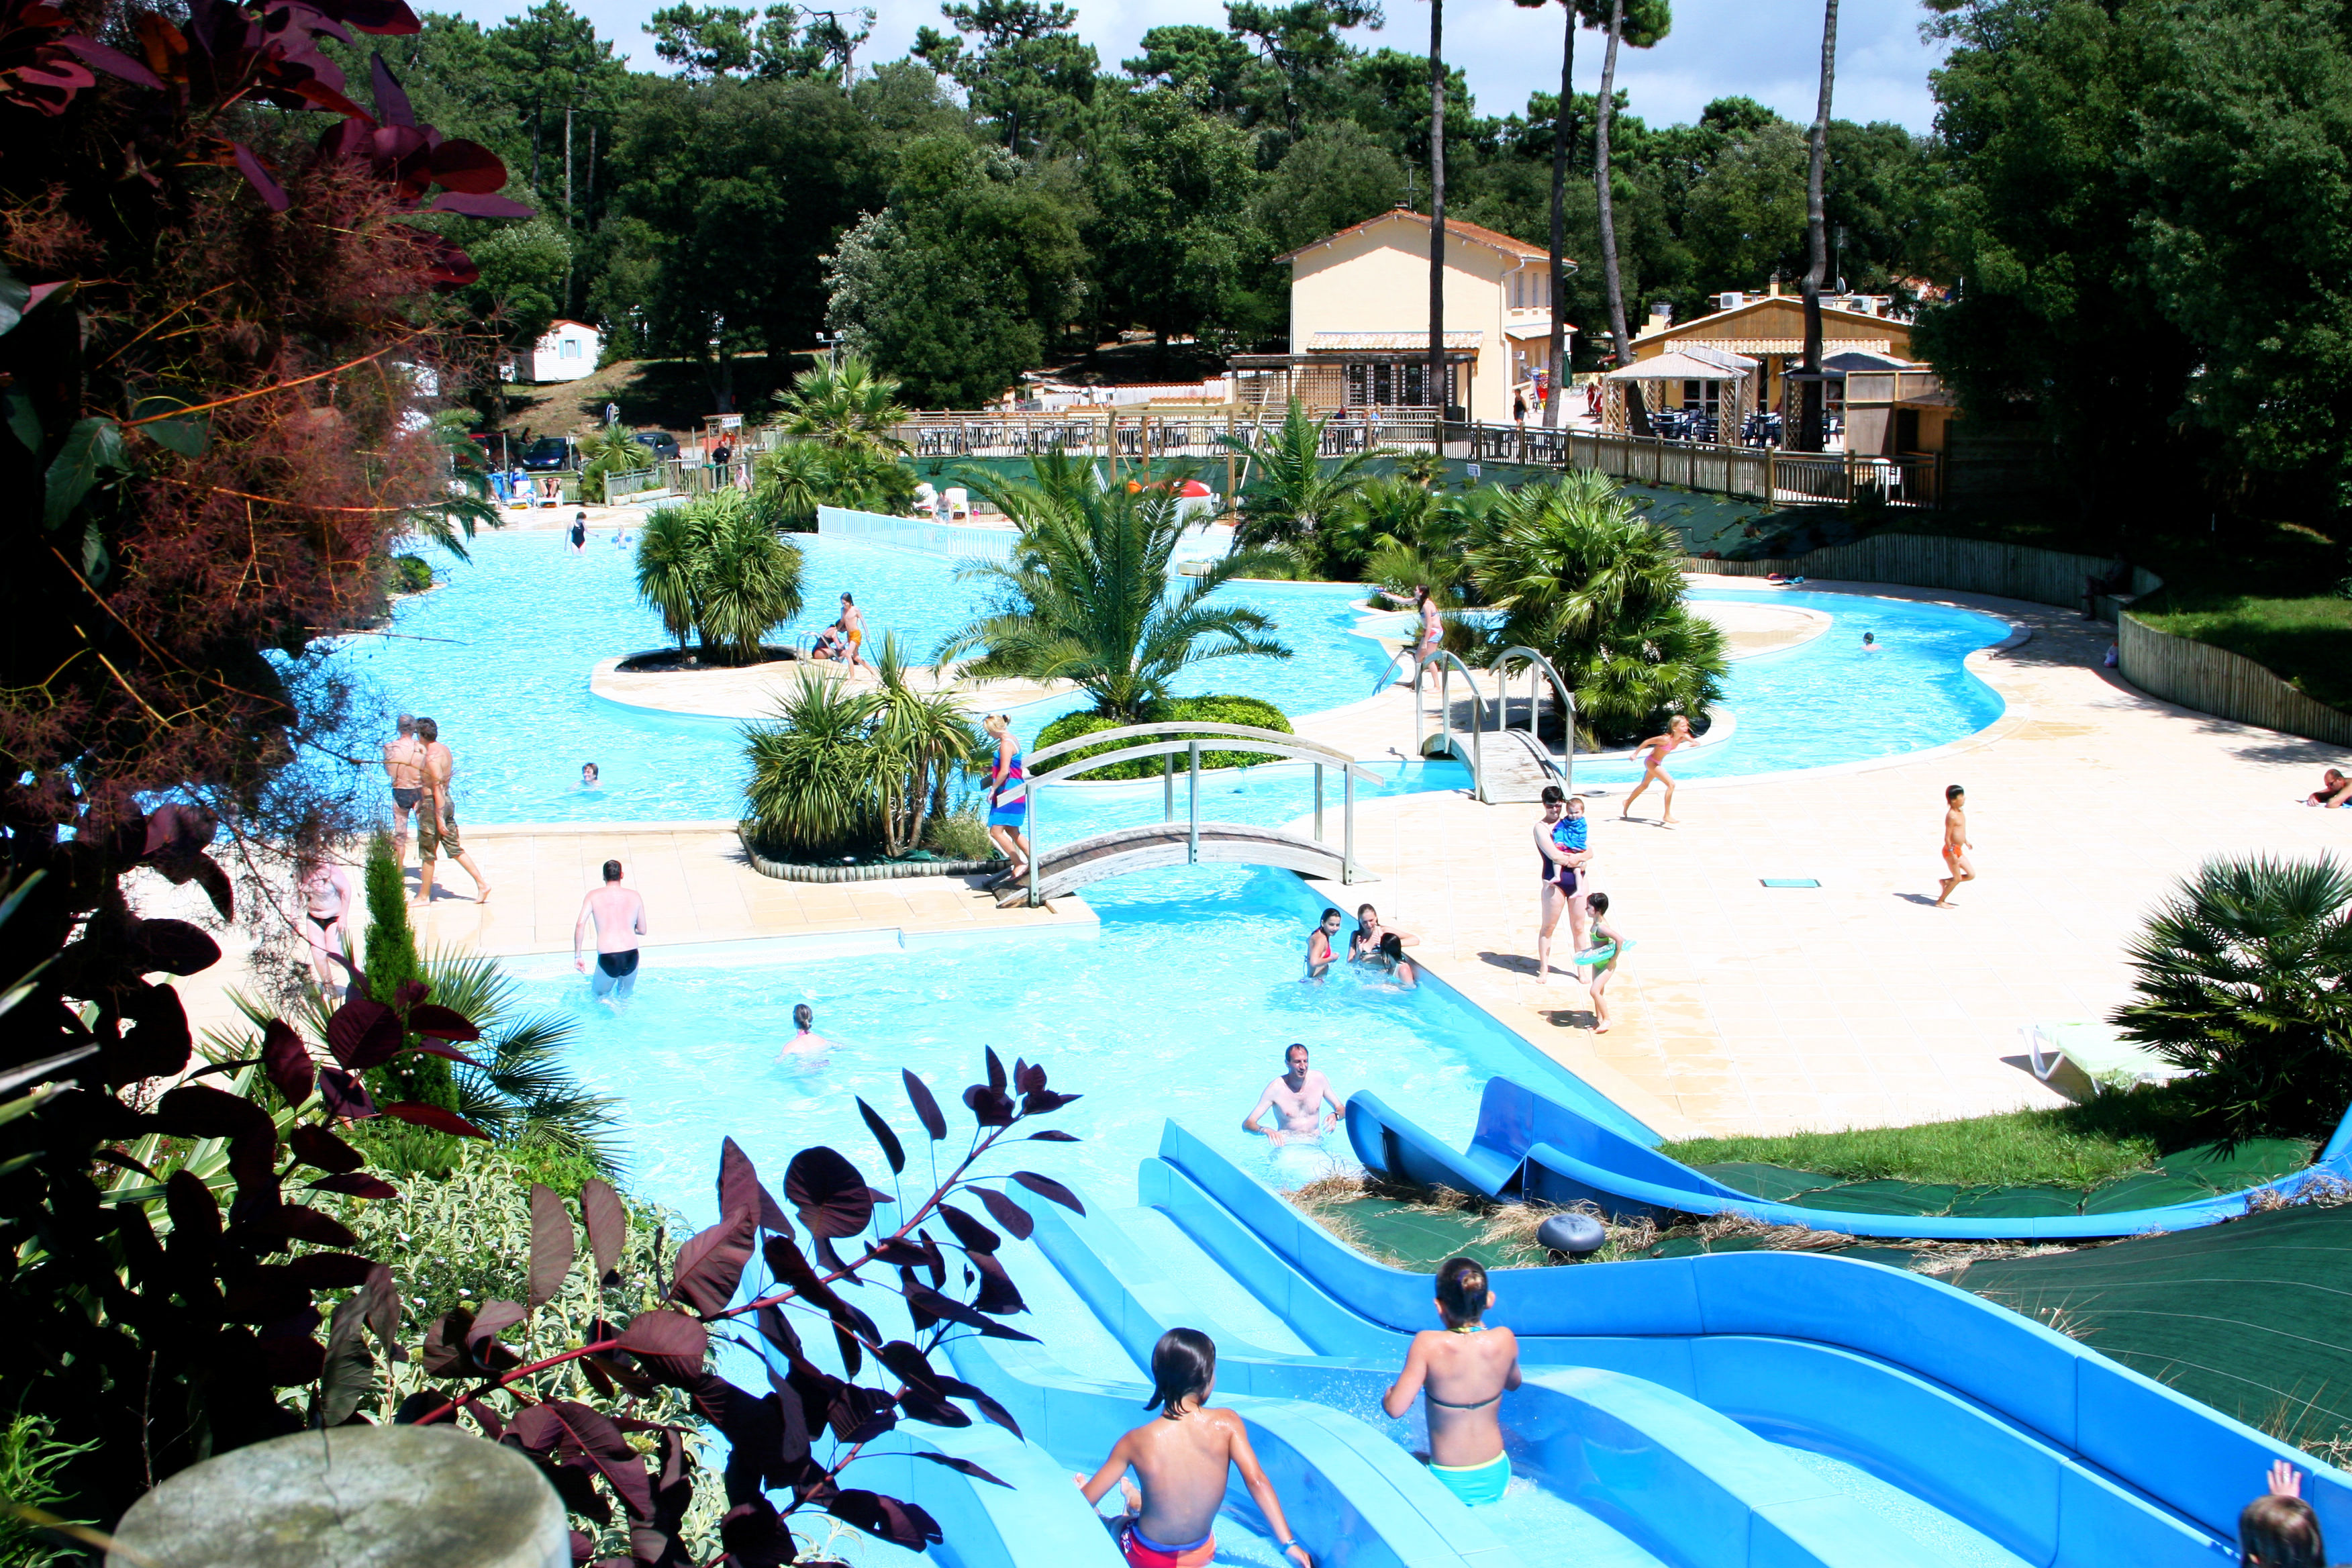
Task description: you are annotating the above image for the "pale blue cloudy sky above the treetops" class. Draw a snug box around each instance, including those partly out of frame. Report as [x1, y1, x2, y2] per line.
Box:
[454, 0, 1941, 132]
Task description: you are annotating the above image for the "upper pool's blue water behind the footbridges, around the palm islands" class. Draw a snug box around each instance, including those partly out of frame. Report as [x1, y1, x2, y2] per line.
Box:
[341, 534, 2008, 839]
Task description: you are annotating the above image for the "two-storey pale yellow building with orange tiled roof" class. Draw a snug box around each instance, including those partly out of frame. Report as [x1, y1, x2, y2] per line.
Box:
[1232, 207, 1573, 423]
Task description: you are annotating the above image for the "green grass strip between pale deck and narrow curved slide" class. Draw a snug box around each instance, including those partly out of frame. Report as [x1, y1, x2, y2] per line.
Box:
[1658, 1086, 2197, 1187]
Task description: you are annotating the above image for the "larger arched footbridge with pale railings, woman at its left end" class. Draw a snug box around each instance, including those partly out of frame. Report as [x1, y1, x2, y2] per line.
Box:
[997, 724, 1381, 908]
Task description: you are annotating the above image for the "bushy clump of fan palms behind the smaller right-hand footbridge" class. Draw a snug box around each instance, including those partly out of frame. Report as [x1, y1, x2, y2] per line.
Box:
[1470, 468, 1728, 745]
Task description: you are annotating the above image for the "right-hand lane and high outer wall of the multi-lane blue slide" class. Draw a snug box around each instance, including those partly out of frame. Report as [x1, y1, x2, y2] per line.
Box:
[1140, 1124, 2352, 1568]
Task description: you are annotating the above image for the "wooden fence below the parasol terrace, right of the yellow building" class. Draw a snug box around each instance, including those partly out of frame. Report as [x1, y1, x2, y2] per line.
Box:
[1467, 426, 1943, 510]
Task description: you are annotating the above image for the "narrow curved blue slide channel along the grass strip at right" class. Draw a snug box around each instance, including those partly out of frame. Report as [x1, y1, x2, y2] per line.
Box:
[1348, 1077, 2352, 1241]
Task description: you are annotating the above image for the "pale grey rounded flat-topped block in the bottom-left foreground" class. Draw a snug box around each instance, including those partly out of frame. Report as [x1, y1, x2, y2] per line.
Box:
[106, 1427, 571, 1568]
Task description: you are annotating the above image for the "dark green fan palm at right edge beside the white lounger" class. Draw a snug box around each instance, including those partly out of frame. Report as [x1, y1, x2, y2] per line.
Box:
[2114, 856, 2352, 1145]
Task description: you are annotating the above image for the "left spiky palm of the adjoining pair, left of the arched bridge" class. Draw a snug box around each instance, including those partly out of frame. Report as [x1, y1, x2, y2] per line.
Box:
[743, 670, 879, 861]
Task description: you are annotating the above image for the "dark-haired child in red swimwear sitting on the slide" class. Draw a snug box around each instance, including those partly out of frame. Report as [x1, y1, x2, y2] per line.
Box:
[1073, 1326, 1317, 1568]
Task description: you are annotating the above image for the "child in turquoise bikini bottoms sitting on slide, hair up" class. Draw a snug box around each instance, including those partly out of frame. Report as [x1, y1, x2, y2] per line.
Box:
[1381, 1258, 1520, 1507]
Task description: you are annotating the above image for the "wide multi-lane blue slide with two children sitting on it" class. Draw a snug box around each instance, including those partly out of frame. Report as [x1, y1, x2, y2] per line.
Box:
[952, 1124, 2352, 1568]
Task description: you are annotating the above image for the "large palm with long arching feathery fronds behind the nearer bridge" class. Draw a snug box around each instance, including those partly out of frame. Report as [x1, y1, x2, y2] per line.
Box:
[938, 460, 1296, 724]
